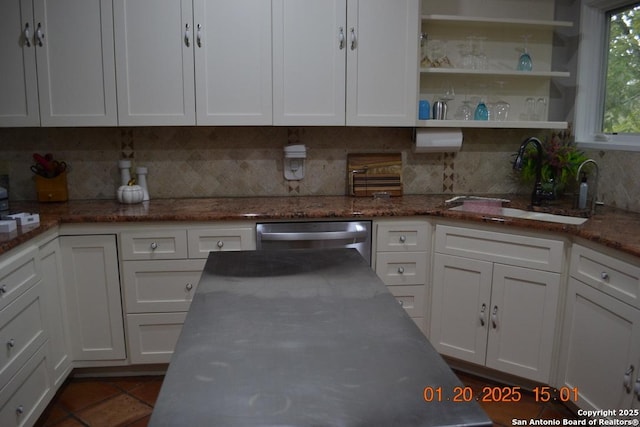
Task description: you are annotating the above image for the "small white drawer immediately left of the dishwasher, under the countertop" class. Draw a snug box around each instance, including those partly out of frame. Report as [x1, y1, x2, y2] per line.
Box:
[187, 226, 256, 258]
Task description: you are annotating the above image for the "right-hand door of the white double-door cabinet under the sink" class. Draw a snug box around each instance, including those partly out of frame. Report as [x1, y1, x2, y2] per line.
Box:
[486, 264, 560, 383]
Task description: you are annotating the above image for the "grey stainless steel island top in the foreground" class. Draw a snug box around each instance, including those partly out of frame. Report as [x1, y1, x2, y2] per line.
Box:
[149, 249, 492, 427]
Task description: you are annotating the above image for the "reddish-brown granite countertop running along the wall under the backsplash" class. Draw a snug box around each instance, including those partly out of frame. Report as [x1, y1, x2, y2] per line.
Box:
[0, 194, 640, 257]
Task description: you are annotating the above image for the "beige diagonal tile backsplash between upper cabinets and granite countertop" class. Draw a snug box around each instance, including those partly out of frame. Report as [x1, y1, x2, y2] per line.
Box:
[0, 127, 640, 212]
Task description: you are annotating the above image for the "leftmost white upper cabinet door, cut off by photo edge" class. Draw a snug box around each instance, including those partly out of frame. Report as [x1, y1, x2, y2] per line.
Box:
[0, 0, 40, 126]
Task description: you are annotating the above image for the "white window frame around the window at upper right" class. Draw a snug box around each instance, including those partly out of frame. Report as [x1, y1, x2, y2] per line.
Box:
[574, 0, 640, 151]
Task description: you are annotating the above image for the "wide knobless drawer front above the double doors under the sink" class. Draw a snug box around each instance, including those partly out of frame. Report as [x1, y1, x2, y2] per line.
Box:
[435, 225, 564, 273]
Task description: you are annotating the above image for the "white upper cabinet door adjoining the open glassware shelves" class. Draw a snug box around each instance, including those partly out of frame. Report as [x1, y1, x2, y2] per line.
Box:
[347, 0, 420, 126]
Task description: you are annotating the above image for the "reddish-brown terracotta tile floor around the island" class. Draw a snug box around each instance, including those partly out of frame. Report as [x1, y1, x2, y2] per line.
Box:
[36, 372, 575, 427]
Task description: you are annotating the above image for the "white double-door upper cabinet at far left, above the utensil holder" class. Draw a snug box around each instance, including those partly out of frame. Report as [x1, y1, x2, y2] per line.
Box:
[0, 0, 117, 126]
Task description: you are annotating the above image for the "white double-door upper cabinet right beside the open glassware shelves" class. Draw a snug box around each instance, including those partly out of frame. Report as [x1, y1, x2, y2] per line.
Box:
[273, 0, 420, 126]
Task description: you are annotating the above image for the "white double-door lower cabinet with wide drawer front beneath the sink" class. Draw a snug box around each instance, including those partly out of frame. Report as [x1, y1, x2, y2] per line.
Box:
[430, 225, 563, 383]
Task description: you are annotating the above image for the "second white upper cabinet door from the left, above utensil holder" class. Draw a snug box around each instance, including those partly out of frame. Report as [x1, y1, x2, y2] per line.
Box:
[33, 0, 117, 126]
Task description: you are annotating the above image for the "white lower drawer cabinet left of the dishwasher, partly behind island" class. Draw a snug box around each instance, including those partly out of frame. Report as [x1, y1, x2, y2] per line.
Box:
[119, 223, 256, 364]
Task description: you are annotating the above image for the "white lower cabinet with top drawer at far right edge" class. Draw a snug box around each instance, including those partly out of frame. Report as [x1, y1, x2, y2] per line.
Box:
[557, 245, 640, 412]
